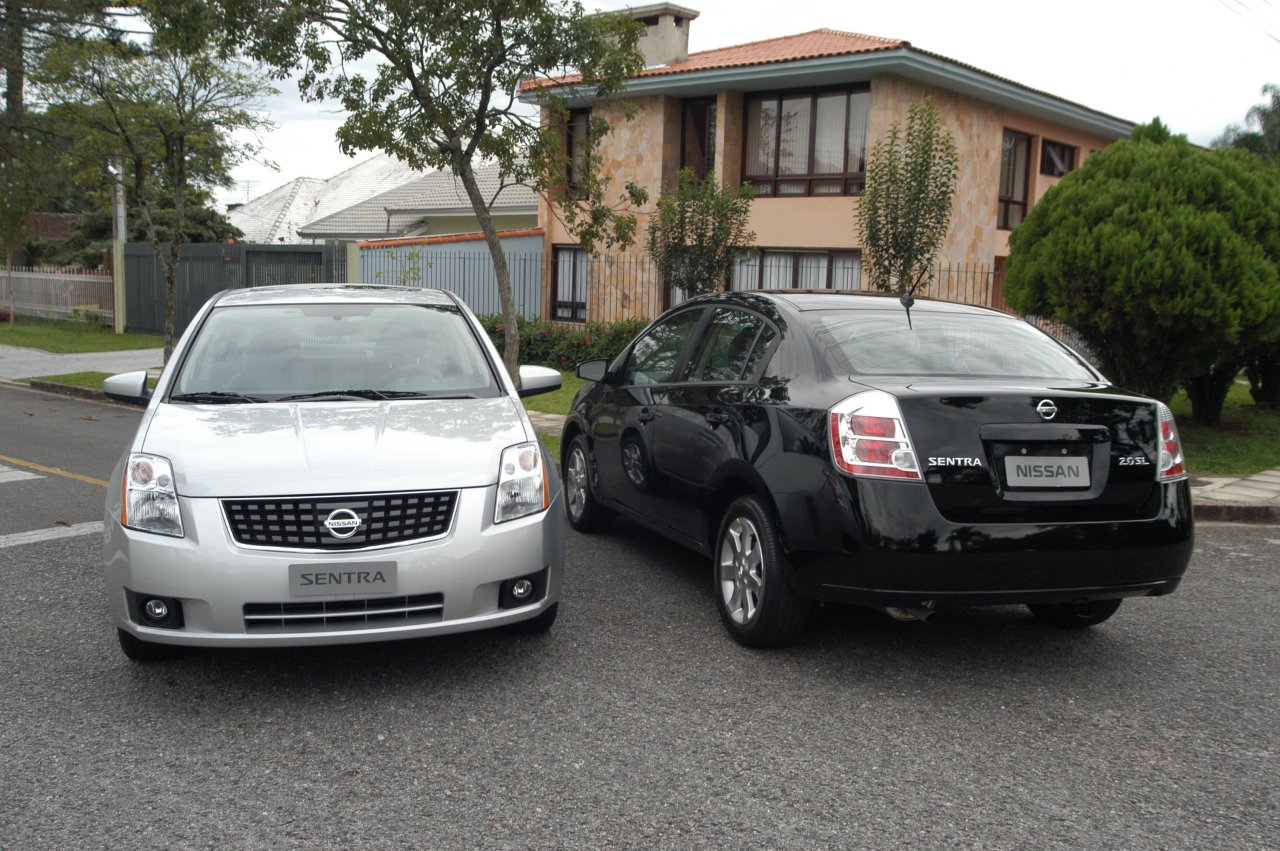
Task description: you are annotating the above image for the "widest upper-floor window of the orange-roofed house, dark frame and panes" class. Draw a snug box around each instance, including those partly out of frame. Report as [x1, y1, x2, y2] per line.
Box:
[742, 87, 870, 197]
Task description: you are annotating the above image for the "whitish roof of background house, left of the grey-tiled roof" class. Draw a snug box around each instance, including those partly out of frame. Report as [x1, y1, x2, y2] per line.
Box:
[227, 154, 421, 243]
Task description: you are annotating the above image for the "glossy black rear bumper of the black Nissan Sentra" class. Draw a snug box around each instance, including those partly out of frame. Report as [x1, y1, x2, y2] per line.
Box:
[778, 479, 1194, 605]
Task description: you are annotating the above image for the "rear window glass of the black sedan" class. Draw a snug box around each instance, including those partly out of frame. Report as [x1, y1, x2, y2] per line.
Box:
[810, 310, 1100, 381]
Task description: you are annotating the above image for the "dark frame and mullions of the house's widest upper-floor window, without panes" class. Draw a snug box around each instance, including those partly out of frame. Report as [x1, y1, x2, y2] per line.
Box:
[741, 83, 870, 198]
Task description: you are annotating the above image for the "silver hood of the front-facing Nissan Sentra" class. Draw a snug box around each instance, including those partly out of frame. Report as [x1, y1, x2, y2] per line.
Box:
[140, 397, 532, 497]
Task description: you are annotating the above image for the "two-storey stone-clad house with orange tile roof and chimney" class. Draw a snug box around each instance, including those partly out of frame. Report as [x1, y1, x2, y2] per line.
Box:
[521, 4, 1133, 321]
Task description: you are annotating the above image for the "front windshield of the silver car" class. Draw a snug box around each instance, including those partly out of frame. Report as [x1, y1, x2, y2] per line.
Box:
[170, 302, 499, 402]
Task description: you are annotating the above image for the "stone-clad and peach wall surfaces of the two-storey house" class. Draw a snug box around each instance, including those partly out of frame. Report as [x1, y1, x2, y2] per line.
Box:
[541, 74, 1126, 321]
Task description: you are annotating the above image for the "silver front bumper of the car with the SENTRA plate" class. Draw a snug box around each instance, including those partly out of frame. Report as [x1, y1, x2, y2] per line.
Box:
[104, 486, 564, 648]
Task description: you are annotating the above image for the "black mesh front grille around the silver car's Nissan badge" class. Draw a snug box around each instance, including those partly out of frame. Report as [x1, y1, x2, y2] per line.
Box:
[223, 490, 458, 550]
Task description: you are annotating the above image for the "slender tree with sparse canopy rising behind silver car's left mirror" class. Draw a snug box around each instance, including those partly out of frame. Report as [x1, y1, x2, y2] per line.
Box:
[40, 41, 270, 361]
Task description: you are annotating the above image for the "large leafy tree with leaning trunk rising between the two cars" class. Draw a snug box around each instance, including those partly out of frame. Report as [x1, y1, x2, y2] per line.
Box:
[161, 0, 644, 376]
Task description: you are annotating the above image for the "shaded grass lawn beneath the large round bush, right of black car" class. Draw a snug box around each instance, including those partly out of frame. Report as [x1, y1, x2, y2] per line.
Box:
[1169, 381, 1280, 476]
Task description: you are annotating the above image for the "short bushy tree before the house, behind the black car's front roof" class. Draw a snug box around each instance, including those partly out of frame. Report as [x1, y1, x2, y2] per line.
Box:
[649, 168, 755, 296]
